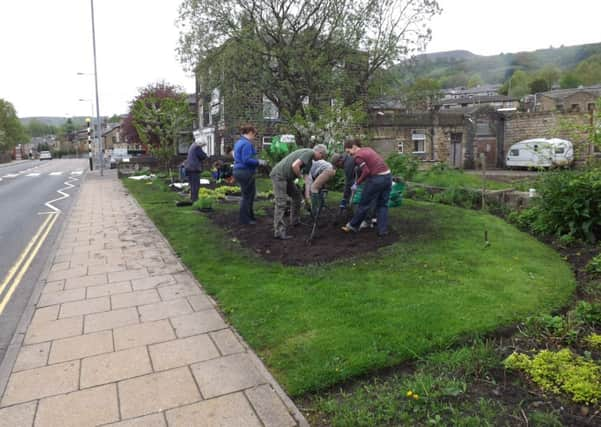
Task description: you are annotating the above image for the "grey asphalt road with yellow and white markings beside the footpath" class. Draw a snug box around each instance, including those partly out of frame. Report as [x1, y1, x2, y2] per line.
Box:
[0, 159, 88, 361]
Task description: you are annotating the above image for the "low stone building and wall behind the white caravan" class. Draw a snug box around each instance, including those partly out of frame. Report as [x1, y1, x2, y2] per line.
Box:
[369, 106, 601, 169]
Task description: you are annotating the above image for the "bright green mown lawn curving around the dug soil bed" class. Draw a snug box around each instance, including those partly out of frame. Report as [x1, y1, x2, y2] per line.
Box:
[124, 180, 575, 395]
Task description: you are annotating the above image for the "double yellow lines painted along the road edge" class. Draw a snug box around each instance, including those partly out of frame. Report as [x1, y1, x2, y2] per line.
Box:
[0, 212, 59, 315]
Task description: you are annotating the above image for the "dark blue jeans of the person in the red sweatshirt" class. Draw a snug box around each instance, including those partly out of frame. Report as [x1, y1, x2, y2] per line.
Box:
[350, 174, 392, 234]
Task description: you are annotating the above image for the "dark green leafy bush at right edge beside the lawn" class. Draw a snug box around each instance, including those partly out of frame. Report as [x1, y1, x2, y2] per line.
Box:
[532, 169, 601, 242]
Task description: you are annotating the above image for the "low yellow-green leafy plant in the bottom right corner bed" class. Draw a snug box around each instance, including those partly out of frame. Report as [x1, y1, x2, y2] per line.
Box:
[503, 348, 601, 404]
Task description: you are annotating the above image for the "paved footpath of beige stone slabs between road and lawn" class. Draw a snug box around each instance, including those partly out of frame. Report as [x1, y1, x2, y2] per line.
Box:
[0, 170, 308, 427]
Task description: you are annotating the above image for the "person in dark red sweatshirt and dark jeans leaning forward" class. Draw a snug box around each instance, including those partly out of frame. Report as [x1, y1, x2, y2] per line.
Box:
[342, 139, 392, 237]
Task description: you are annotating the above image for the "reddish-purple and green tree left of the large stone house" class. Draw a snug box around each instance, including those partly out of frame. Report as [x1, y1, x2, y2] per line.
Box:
[125, 82, 194, 168]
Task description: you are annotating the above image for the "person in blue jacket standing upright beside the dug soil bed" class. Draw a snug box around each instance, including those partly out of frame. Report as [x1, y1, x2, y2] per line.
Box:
[234, 124, 267, 225]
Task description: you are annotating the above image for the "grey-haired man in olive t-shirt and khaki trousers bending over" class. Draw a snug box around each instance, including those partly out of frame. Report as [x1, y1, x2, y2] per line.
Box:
[269, 144, 328, 240]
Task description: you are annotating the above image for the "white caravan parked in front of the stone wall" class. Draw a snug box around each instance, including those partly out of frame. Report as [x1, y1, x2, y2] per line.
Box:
[505, 138, 574, 168]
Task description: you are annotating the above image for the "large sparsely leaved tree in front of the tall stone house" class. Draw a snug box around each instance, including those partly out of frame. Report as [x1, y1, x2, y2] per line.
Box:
[178, 0, 440, 144]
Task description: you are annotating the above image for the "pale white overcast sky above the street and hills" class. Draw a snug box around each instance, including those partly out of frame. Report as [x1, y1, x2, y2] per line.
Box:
[0, 0, 601, 117]
